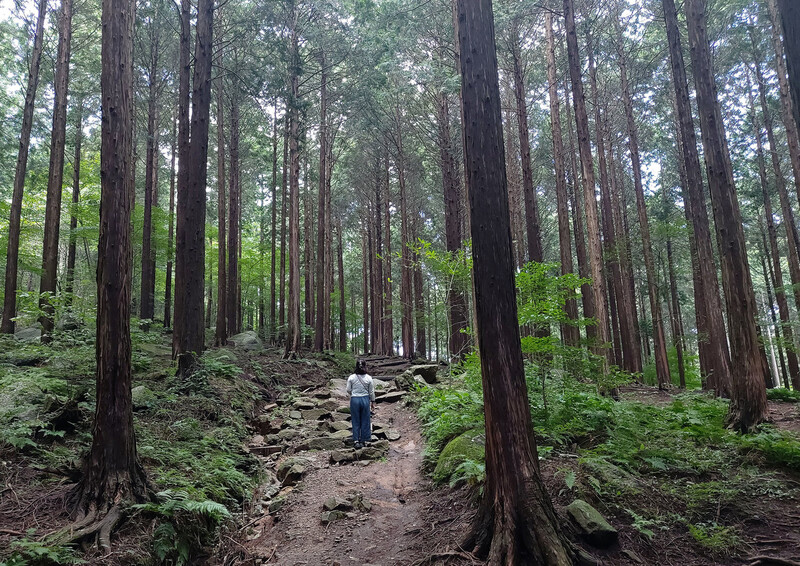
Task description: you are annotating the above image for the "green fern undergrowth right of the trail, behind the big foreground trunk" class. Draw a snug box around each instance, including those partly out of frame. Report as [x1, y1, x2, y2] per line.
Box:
[418, 356, 800, 556]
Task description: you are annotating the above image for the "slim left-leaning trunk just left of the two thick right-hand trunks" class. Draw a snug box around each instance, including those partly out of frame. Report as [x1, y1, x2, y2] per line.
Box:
[617, 29, 672, 389]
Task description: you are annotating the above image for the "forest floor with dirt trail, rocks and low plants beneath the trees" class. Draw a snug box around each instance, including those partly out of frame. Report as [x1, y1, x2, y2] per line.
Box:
[0, 332, 800, 566]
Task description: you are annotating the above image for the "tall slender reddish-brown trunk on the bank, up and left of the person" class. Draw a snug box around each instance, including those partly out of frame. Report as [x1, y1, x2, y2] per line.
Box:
[284, 0, 302, 358]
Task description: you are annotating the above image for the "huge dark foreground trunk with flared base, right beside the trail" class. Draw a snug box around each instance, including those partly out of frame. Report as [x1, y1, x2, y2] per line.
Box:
[456, 0, 572, 566]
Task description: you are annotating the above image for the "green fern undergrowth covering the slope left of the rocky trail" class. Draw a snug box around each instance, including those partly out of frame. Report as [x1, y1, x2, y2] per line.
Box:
[0, 323, 262, 566]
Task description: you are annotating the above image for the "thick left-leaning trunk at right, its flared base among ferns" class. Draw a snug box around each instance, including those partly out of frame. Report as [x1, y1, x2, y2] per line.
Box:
[685, 0, 767, 432]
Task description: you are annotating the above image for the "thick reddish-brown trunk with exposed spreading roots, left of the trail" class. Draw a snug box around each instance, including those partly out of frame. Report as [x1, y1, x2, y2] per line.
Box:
[73, 0, 147, 520]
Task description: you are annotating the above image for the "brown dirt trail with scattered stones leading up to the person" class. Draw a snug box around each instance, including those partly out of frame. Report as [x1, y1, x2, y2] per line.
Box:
[242, 366, 460, 566]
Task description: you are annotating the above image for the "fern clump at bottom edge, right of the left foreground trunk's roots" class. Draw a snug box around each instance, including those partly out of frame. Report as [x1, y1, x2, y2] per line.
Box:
[133, 490, 231, 566]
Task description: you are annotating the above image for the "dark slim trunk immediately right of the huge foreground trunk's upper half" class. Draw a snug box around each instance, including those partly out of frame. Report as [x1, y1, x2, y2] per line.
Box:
[511, 20, 544, 263]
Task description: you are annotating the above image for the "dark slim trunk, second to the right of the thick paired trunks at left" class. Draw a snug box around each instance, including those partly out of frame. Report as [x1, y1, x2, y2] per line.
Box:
[225, 86, 242, 336]
